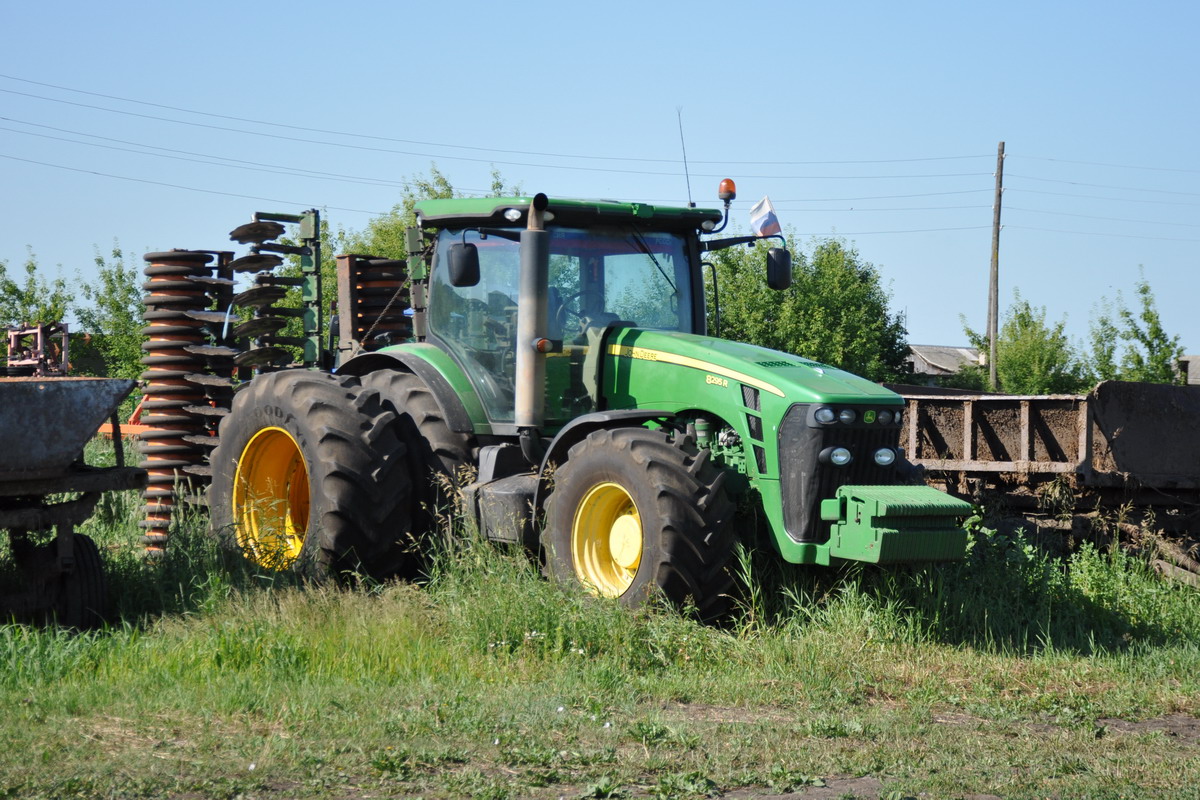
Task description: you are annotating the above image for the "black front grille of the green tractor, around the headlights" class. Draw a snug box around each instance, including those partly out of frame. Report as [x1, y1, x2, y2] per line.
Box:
[779, 404, 900, 542]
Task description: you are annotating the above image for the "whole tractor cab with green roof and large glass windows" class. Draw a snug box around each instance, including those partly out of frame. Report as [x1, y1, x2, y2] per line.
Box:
[418, 198, 720, 432]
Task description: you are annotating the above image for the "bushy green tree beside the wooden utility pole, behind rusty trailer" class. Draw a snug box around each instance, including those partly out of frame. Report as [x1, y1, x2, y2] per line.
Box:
[964, 289, 1091, 395]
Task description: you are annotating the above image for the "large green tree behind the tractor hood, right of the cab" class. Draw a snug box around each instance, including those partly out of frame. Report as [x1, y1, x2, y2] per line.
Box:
[708, 239, 908, 380]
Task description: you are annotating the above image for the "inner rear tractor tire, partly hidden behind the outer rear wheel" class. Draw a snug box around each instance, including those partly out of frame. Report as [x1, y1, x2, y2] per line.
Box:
[362, 369, 476, 537]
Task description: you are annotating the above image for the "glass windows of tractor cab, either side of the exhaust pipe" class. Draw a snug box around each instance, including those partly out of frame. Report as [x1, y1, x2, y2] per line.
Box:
[428, 224, 692, 422]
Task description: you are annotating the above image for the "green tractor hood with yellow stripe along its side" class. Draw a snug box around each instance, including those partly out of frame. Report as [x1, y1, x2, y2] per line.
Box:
[605, 329, 904, 408]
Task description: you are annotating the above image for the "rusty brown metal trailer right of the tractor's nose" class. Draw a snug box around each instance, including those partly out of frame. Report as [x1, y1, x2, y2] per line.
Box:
[894, 380, 1200, 522]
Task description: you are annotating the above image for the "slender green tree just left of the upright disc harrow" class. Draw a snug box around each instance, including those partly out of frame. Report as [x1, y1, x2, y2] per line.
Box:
[74, 242, 145, 378]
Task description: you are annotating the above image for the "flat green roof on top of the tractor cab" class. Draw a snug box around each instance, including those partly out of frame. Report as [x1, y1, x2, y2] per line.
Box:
[416, 197, 722, 229]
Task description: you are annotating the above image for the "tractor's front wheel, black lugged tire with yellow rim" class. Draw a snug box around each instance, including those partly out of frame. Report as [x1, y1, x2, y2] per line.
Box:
[542, 428, 737, 619]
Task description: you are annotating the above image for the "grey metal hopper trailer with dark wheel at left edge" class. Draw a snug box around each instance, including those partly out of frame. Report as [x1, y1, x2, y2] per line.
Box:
[0, 378, 146, 628]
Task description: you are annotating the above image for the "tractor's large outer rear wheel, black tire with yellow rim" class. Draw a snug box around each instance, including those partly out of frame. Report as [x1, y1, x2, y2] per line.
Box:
[209, 369, 412, 579]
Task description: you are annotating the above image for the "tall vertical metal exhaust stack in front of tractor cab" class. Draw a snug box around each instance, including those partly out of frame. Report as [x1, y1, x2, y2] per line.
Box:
[515, 193, 550, 467]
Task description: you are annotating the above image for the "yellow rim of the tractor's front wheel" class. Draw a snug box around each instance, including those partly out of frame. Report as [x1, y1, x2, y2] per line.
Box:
[571, 482, 643, 597]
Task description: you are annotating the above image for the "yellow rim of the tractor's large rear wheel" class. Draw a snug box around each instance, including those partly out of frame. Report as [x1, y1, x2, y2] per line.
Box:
[233, 428, 310, 570]
